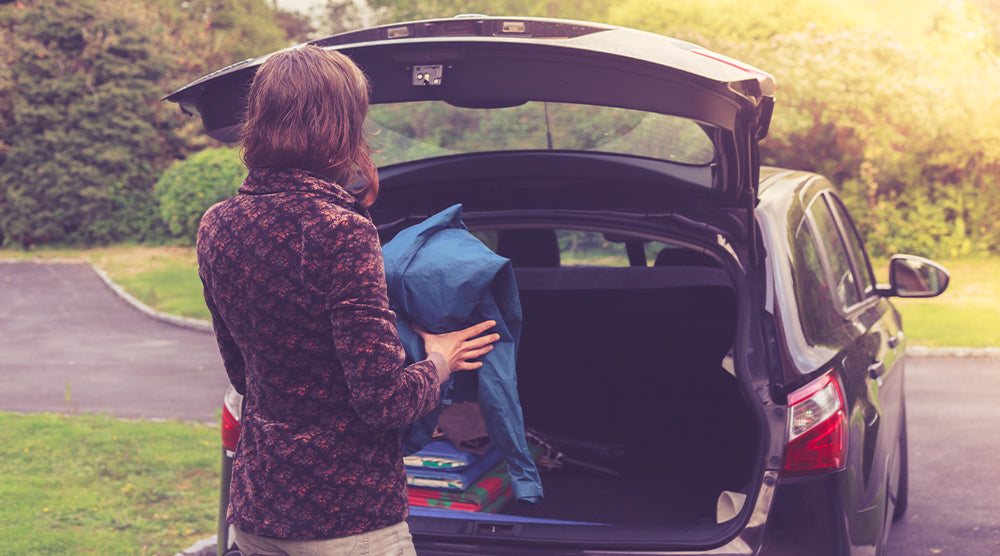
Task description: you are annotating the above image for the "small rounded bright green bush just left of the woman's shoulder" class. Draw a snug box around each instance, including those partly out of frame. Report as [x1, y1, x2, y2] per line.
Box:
[156, 148, 246, 244]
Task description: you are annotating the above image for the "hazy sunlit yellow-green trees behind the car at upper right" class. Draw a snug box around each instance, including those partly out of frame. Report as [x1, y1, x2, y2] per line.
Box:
[609, 0, 1000, 256]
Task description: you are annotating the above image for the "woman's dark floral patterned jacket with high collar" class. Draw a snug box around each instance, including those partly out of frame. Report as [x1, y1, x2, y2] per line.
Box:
[198, 169, 445, 539]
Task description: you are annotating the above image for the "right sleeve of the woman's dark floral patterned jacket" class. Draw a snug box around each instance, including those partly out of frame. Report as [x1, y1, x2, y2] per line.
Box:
[302, 212, 443, 428]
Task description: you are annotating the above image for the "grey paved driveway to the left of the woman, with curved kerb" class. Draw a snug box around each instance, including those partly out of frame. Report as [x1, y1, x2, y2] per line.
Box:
[0, 262, 228, 421]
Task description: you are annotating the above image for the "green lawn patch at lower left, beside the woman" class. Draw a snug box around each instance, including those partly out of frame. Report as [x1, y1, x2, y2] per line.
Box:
[0, 412, 219, 556]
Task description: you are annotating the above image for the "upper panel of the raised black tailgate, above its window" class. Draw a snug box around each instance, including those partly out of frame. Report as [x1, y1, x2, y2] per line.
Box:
[166, 18, 773, 205]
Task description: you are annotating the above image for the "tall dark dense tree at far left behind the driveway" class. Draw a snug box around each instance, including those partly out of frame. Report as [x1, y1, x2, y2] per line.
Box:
[0, 0, 165, 246]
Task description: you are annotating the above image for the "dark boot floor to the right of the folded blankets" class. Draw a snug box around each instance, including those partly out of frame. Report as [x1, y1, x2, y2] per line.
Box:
[502, 470, 722, 527]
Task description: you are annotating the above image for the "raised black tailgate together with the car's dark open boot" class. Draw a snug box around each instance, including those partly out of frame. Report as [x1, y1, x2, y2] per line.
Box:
[167, 17, 774, 554]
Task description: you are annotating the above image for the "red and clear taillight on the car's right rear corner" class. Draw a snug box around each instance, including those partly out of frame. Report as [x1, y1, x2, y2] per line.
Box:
[782, 372, 847, 475]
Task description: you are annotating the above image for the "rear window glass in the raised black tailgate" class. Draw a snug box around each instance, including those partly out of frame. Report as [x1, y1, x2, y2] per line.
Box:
[368, 101, 715, 166]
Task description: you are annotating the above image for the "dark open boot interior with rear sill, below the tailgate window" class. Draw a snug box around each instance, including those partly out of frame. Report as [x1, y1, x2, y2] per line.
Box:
[373, 164, 765, 554]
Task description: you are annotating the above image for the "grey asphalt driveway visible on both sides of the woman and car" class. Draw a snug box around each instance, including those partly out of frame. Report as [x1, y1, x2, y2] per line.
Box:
[0, 262, 1000, 556]
